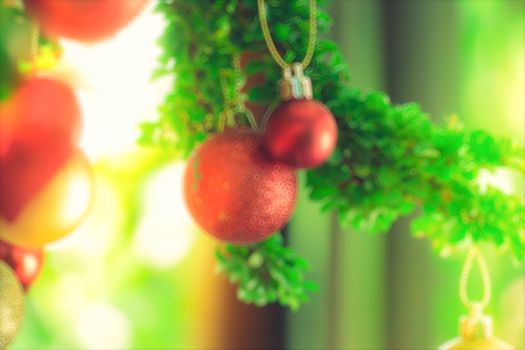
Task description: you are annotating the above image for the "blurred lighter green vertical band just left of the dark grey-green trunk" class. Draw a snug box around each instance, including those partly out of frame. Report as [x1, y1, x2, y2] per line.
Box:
[328, 0, 386, 349]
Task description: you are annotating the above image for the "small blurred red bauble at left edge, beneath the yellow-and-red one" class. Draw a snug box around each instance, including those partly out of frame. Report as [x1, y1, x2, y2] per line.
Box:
[0, 241, 44, 290]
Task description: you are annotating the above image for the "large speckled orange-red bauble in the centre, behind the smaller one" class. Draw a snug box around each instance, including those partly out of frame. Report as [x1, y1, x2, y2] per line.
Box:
[184, 129, 297, 244]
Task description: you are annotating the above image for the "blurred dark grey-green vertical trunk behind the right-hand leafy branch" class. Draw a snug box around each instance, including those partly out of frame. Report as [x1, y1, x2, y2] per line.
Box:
[383, 0, 459, 349]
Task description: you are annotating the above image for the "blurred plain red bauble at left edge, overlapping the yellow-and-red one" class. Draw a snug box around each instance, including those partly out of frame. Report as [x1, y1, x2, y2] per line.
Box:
[0, 78, 80, 221]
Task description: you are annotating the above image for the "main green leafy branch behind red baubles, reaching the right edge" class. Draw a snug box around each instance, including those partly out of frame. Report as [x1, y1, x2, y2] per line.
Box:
[143, 0, 525, 302]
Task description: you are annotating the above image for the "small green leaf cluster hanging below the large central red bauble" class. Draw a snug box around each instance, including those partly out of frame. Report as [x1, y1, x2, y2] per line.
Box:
[216, 234, 317, 310]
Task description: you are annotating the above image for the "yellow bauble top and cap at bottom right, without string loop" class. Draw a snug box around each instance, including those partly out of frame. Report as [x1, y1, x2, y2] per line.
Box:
[439, 303, 514, 350]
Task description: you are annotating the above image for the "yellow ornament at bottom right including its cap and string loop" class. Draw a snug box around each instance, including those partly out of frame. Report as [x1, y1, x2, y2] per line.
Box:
[439, 247, 514, 350]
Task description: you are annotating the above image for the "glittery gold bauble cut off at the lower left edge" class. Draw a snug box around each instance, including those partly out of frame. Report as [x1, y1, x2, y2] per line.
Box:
[0, 260, 24, 349]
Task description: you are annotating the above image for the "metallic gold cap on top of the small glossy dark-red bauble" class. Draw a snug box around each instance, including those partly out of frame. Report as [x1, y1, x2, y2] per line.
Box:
[279, 63, 313, 101]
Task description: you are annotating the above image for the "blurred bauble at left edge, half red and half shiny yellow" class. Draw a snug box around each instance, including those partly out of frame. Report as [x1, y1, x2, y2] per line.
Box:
[0, 149, 94, 248]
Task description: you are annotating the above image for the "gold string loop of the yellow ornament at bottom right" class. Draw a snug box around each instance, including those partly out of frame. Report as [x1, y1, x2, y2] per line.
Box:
[459, 246, 491, 308]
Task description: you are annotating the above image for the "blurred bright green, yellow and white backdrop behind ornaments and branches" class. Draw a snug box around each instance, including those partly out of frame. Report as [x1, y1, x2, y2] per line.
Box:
[12, 0, 525, 350]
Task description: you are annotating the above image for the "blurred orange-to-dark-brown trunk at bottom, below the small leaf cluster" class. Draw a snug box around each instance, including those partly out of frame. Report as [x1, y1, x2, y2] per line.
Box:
[189, 238, 285, 350]
